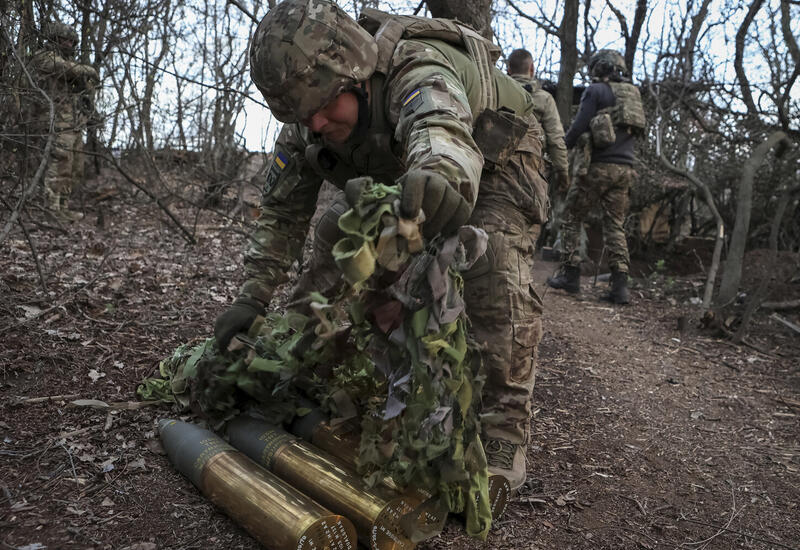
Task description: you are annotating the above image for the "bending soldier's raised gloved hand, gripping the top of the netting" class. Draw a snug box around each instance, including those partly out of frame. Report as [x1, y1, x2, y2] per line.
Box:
[397, 170, 472, 239]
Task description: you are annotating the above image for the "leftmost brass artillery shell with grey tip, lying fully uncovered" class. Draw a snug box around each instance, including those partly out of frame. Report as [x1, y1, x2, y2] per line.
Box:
[159, 421, 356, 550]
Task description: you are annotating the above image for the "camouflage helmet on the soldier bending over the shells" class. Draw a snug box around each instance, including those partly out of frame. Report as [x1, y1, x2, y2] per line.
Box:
[250, 0, 378, 122]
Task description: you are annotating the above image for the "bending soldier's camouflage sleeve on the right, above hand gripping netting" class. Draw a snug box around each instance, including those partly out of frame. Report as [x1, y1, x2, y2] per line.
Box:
[386, 40, 483, 206]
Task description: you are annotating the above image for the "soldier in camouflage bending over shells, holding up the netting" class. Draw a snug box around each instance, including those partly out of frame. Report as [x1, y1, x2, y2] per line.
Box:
[214, 0, 548, 488]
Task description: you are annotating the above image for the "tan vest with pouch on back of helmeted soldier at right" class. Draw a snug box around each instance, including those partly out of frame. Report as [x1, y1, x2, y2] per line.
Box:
[589, 82, 645, 149]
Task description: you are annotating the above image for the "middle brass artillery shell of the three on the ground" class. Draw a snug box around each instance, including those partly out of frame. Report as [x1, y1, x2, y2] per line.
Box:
[223, 417, 417, 550]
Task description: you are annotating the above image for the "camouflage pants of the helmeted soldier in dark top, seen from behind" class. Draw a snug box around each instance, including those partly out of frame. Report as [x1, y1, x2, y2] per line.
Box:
[562, 163, 636, 273]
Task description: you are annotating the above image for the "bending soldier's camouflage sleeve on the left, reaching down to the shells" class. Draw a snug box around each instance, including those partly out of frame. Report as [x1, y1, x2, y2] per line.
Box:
[240, 124, 322, 305]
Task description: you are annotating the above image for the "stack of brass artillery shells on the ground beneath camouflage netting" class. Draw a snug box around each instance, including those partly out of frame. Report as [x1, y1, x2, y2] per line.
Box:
[159, 411, 509, 550]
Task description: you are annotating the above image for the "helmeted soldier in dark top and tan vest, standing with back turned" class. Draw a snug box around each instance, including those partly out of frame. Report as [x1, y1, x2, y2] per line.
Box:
[547, 50, 645, 304]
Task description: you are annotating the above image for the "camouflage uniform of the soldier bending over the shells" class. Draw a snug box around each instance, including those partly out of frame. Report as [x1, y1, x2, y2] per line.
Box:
[234, 0, 548, 488]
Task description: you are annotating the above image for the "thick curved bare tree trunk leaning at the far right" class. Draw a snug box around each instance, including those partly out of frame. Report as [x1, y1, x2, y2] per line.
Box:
[717, 132, 786, 307]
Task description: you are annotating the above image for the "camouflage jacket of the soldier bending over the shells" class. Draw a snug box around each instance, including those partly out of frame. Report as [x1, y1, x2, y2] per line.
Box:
[241, 39, 534, 304]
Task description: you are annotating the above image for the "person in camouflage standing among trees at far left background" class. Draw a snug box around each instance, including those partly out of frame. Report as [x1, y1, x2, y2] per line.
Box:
[31, 22, 100, 219]
